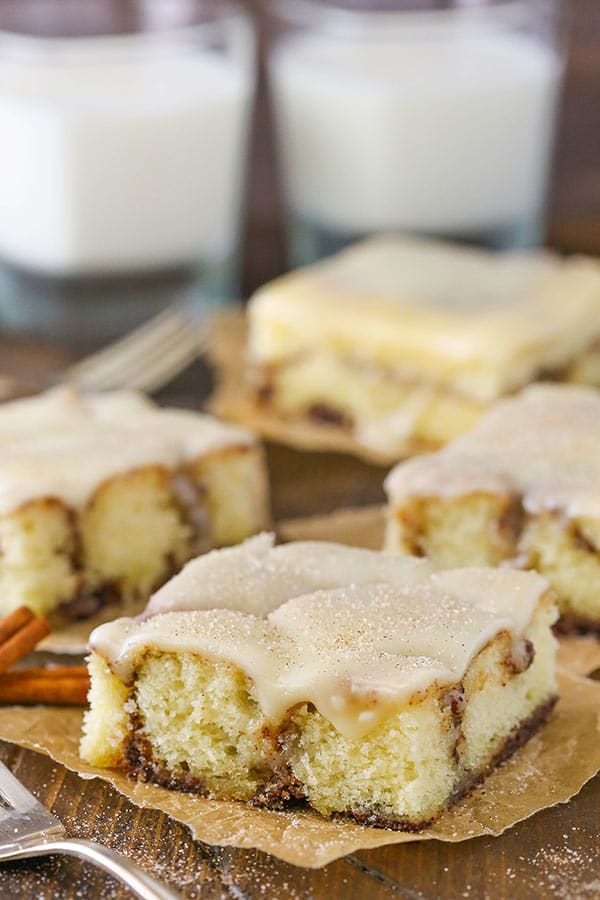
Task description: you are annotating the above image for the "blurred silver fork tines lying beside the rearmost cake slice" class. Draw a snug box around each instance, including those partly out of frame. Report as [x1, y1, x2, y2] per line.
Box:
[63, 307, 209, 392]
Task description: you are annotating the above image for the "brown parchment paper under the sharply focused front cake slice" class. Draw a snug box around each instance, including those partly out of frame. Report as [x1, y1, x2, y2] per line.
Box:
[0, 673, 600, 868]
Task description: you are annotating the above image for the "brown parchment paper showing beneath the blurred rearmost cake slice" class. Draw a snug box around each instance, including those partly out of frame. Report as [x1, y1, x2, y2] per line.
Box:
[208, 311, 398, 466]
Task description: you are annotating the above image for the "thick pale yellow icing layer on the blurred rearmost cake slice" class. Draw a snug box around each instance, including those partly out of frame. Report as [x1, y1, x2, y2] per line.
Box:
[249, 236, 600, 402]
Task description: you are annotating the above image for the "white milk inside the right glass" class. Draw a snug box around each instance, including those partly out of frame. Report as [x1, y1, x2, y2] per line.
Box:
[271, 29, 561, 235]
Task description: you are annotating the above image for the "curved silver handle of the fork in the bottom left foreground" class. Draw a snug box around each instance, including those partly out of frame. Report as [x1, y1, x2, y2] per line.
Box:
[4, 838, 178, 900]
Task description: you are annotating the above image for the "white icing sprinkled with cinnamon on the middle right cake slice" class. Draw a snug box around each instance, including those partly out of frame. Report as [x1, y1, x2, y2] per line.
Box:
[385, 385, 600, 518]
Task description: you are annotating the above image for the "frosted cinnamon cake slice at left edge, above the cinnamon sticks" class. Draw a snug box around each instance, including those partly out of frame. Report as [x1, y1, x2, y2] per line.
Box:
[0, 388, 267, 618]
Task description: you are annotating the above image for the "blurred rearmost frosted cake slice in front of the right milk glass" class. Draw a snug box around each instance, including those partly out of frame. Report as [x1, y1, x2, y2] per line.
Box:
[248, 237, 600, 462]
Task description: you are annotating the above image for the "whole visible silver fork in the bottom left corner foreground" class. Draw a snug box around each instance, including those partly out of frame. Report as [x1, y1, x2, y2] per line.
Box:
[0, 763, 177, 900]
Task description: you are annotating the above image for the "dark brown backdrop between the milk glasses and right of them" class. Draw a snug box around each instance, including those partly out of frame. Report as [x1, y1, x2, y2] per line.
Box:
[243, 0, 600, 292]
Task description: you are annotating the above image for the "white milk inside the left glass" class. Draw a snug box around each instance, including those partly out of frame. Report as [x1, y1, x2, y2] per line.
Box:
[0, 51, 251, 274]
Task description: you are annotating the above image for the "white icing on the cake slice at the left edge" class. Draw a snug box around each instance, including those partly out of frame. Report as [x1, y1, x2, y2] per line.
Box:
[0, 387, 253, 514]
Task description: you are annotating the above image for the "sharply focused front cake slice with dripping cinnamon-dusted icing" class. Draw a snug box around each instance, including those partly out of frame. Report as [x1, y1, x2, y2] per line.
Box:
[81, 536, 556, 829]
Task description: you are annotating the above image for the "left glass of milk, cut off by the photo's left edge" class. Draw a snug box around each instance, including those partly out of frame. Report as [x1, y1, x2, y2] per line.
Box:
[0, 0, 254, 342]
